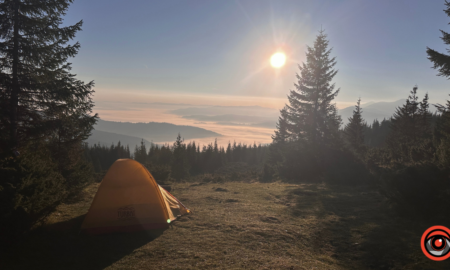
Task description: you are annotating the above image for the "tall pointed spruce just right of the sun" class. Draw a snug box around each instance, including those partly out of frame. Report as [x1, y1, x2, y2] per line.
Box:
[278, 31, 341, 145]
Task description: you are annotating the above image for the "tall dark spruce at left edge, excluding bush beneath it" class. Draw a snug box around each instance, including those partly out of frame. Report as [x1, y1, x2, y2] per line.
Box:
[0, 0, 96, 151]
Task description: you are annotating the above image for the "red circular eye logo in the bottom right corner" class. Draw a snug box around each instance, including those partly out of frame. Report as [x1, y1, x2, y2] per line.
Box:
[420, 226, 450, 261]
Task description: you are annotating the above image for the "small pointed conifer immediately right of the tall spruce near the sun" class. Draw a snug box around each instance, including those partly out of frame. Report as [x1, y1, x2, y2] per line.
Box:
[344, 98, 366, 152]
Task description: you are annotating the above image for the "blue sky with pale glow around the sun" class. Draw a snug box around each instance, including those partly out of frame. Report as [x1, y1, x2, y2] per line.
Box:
[65, 0, 450, 108]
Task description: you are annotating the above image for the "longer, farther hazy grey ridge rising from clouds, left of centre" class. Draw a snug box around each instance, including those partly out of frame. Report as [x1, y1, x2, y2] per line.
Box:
[94, 119, 222, 143]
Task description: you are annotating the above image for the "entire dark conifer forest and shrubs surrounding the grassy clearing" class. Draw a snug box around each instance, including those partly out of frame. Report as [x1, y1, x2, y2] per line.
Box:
[0, 0, 450, 251]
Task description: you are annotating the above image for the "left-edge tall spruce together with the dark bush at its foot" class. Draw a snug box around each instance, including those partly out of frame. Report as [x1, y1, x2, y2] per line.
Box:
[0, 0, 96, 243]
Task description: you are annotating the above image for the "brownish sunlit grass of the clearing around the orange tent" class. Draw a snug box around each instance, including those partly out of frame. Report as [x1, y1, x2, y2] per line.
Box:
[0, 182, 450, 269]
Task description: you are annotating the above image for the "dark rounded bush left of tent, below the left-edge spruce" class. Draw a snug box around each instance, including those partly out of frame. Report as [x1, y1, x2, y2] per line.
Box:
[0, 149, 68, 248]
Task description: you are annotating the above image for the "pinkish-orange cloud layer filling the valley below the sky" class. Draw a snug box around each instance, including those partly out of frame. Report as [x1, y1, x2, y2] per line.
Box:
[90, 99, 434, 148]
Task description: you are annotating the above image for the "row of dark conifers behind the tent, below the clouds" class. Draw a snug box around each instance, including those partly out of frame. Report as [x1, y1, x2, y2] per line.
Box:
[84, 135, 268, 183]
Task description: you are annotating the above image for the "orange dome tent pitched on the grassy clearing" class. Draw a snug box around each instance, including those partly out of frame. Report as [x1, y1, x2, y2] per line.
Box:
[81, 159, 190, 234]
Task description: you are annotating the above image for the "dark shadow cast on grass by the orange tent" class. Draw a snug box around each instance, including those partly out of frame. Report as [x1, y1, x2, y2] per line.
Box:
[2, 215, 164, 269]
